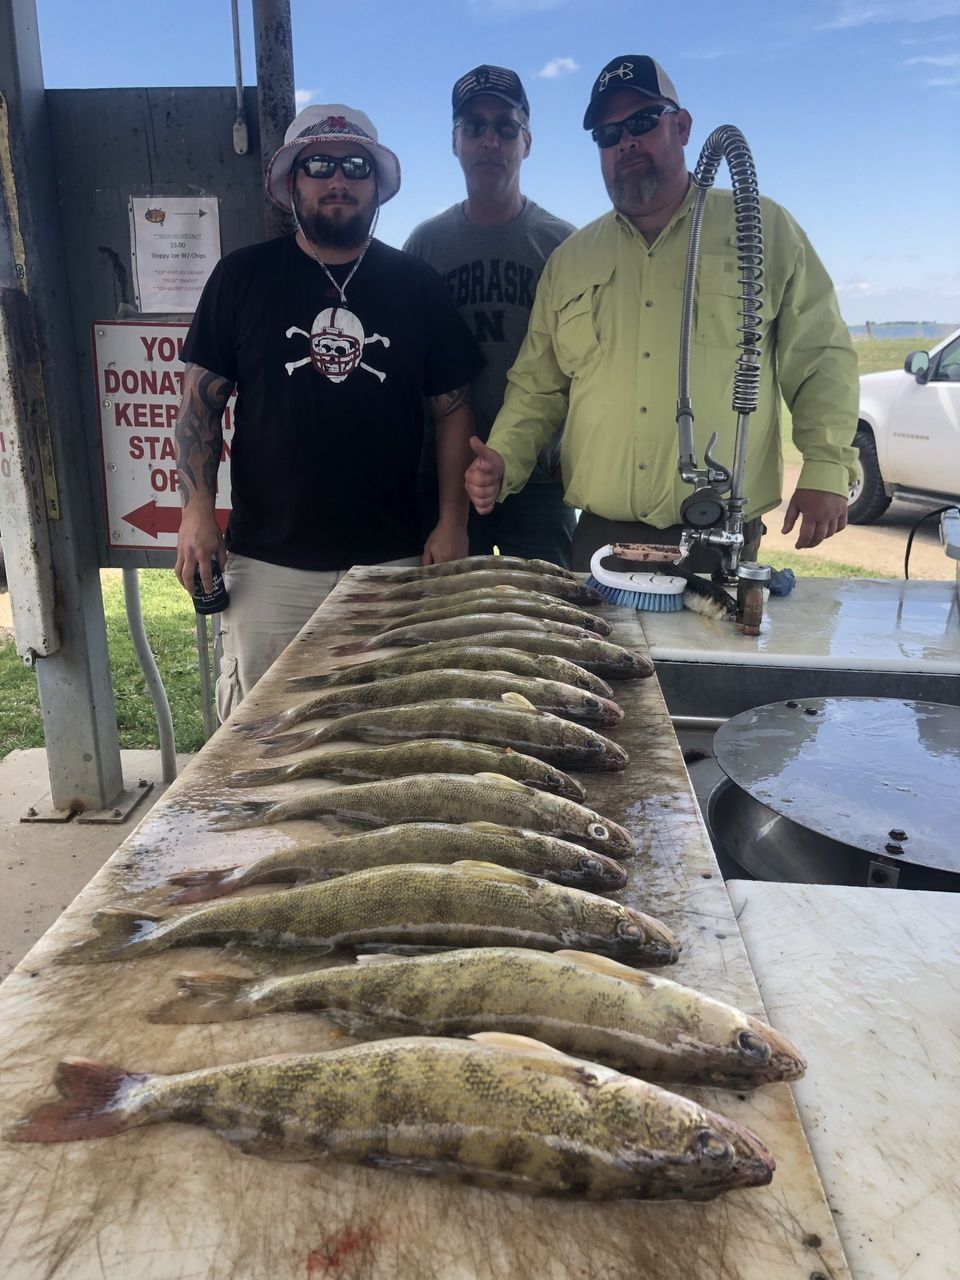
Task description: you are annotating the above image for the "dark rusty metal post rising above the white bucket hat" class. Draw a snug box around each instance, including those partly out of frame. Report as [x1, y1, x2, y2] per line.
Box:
[253, 0, 296, 239]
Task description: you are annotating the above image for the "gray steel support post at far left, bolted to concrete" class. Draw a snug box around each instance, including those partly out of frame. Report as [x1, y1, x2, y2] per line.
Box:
[0, 0, 123, 815]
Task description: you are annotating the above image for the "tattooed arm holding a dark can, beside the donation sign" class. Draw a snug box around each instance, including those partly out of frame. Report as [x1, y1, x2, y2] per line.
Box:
[174, 365, 233, 594]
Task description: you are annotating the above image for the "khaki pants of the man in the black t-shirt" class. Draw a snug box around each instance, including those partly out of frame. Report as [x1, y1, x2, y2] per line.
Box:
[216, 552, 420, 723]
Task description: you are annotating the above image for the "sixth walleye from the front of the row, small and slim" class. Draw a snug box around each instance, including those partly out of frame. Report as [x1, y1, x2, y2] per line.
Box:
[228, 737, 586, 800]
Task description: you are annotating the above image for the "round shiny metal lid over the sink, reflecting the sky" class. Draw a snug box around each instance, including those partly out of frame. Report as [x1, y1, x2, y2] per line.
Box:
[713, 698, 960, 870]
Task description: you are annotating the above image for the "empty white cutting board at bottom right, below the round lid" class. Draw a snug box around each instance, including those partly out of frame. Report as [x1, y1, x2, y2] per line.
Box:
[727, 881, 960, 1280]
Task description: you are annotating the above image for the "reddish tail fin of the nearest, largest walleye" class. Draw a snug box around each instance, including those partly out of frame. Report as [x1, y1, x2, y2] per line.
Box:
[6, 1057, 150, 1142]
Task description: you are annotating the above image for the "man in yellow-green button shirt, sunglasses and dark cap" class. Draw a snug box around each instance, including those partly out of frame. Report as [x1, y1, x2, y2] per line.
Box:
[466, 54, 858, 571]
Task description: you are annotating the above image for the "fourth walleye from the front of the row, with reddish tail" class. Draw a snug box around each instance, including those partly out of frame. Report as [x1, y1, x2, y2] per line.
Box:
[169, 822, 627, 905]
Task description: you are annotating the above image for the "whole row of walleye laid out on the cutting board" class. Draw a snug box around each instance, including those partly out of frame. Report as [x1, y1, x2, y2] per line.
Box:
[12, 557, 805, 1199]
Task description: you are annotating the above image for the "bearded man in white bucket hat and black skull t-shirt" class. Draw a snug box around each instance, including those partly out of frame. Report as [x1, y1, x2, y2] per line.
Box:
[175, 104, 483, 719]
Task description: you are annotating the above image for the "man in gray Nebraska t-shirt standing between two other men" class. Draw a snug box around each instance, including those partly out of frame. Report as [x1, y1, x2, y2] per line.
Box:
[404, 67, 576, 564]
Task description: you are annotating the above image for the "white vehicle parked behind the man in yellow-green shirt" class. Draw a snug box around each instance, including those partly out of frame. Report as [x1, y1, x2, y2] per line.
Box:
[847, 329, 960, 525]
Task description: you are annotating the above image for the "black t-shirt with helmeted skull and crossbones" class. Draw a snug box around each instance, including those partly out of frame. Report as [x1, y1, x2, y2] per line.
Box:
[183, 236, 484, 570]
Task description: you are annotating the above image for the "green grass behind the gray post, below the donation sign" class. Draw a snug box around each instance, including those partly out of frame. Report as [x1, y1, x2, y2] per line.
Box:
[0, 570, 204, 758]
